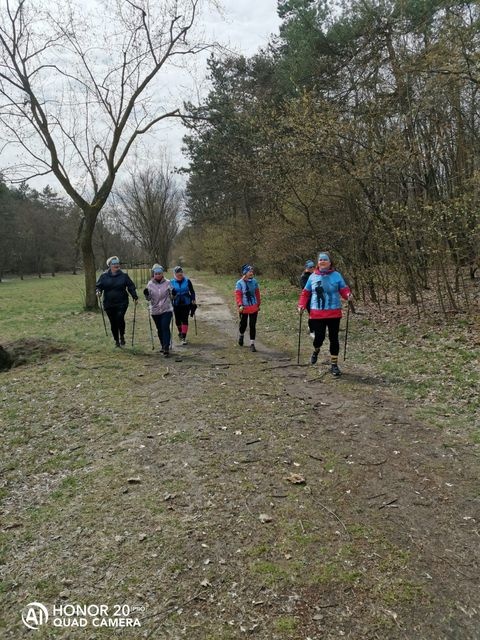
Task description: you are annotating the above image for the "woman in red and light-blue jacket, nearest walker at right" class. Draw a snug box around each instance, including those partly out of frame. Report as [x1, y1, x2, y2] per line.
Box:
[298, 251, 352, 376]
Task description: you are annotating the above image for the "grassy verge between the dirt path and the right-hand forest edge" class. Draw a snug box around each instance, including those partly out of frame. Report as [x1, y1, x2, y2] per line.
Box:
[197, 273, 480, 443]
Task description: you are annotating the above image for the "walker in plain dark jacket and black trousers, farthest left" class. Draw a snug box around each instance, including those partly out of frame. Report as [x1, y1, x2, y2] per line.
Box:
[95, 256, 138, 347]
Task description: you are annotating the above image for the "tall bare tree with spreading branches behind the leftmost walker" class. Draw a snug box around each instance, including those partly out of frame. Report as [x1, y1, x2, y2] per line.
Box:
[0, 0, 208, 309]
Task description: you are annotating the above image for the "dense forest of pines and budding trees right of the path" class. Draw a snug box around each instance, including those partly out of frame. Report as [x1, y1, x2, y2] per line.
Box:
[181, 0, 480, 312]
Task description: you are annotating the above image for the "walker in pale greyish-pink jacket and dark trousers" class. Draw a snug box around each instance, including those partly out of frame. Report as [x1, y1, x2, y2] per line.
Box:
[143, 264, 173, 358]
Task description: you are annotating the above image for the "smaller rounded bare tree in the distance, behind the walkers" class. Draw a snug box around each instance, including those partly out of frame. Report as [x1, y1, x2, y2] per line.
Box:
[114, 165, 183, 266]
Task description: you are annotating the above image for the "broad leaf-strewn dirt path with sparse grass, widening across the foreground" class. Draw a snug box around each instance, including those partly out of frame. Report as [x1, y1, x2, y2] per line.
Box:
[4, 282, 480, 640]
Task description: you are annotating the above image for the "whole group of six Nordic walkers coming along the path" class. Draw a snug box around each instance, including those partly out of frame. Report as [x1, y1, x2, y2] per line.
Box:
[96, 252, 353, 376]
